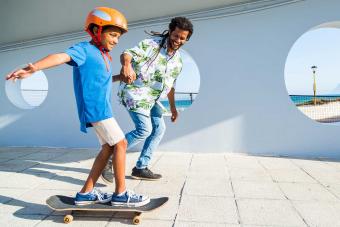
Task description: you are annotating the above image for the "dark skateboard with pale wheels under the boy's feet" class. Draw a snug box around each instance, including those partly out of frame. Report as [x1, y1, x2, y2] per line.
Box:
[46, 195, 169, 225]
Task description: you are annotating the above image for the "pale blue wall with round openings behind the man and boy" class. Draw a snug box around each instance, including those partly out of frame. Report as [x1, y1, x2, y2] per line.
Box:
[0, 0, 340, 157]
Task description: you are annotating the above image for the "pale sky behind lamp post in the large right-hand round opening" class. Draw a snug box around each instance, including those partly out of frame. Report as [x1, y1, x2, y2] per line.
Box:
[285, 28, 340, 95]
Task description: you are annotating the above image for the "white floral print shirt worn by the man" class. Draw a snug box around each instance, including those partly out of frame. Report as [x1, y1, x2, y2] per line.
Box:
[118, 37, 182, 116]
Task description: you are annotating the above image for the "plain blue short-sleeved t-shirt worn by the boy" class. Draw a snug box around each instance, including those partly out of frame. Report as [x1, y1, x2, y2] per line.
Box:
[65, 42, 112, 133]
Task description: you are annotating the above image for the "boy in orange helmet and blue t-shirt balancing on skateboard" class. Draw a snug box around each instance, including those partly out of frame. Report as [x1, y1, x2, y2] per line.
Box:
[6, 7, 150, 207]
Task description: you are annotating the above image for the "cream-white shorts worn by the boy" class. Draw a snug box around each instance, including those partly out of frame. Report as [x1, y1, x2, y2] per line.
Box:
[92, 117, 125, 146]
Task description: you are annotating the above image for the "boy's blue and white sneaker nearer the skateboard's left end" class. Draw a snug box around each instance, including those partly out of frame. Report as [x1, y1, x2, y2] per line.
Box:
[74, 188, 112, 205]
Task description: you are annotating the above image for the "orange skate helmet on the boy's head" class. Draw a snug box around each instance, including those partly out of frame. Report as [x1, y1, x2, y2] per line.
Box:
[85, 7, 128, 33]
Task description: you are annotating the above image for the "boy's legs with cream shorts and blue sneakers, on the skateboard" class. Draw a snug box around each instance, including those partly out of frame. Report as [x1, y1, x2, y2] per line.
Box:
[75, 118, 150, 207]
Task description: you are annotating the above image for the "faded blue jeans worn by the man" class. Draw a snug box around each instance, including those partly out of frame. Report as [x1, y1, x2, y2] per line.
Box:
[125, 104, 165, 169]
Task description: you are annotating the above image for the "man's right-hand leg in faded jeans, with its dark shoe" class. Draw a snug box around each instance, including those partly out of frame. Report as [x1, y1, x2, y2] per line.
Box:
[132, 104, 166, 180]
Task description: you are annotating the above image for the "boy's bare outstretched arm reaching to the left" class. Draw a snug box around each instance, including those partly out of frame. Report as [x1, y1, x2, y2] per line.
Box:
[6, 53, 71, 80]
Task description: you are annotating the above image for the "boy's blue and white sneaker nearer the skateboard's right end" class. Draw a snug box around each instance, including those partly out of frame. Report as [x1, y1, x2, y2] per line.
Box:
[111, 190, 150, 207]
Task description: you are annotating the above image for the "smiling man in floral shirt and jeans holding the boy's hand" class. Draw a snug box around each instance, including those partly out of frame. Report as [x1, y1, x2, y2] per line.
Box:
[102, 17, 193, 182]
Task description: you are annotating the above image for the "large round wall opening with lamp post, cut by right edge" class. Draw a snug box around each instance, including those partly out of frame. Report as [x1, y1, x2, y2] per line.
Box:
[285, 22, 340, 123]
